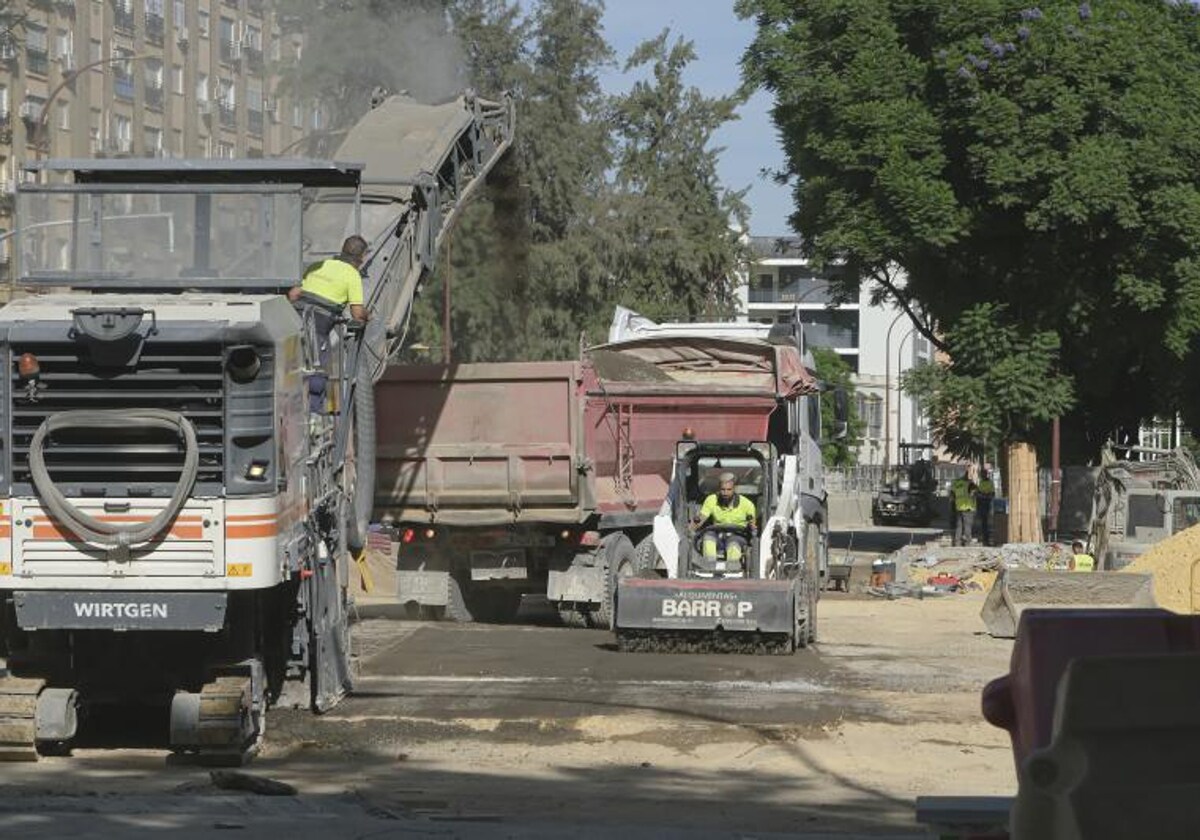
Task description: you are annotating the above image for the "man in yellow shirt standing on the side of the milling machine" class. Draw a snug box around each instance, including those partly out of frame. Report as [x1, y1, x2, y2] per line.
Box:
[288, 236, 368, 414]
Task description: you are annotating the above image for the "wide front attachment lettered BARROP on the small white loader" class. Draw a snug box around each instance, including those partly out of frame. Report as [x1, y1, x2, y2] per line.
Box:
[616, 577, 800, 653]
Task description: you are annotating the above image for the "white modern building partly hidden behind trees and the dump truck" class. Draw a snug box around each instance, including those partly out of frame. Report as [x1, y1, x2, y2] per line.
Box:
[738, 236, 934, 464]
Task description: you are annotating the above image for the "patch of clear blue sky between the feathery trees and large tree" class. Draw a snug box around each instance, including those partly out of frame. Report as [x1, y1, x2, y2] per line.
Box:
[602, 0, 792, 236]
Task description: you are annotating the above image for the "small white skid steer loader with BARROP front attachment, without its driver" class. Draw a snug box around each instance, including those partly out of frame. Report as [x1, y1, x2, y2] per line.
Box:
[614, 440, 826, 654]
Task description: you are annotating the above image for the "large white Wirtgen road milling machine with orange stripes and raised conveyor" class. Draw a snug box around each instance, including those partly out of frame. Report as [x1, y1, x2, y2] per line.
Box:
[0, 96, 512, 762]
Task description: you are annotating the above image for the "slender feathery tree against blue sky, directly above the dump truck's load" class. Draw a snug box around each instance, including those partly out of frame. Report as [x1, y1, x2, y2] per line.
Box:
[612, 30, 746, 320]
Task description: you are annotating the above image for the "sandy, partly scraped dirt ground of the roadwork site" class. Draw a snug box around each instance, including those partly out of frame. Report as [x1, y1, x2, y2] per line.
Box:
[0, 583, 1015, 840]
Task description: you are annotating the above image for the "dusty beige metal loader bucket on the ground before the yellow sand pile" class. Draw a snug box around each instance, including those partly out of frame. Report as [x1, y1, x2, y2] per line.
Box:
[980, 569, 1154, 638]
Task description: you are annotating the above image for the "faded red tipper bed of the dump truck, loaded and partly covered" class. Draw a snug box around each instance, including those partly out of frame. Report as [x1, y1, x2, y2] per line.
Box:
[376, 337, 815, 527]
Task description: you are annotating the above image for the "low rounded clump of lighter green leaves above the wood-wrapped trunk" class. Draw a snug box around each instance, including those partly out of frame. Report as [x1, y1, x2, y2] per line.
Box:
[900, 304, 1074, 460]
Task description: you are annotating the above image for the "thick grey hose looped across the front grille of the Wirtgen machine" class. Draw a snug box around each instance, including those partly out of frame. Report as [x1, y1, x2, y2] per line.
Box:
[29, 408, 200, 547]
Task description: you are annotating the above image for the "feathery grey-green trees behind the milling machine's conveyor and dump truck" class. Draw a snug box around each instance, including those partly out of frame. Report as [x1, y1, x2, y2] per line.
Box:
[414, 0, 744, 361]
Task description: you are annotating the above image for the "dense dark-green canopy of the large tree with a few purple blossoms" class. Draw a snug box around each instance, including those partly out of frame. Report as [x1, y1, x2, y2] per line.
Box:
[738, 0, 1200, 455]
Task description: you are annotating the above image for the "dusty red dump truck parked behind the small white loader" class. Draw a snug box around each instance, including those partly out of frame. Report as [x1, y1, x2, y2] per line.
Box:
[374, 309, 844, 629]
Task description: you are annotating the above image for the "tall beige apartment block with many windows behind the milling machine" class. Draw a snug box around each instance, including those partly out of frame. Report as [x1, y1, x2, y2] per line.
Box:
[0, 0, 323, 268]
